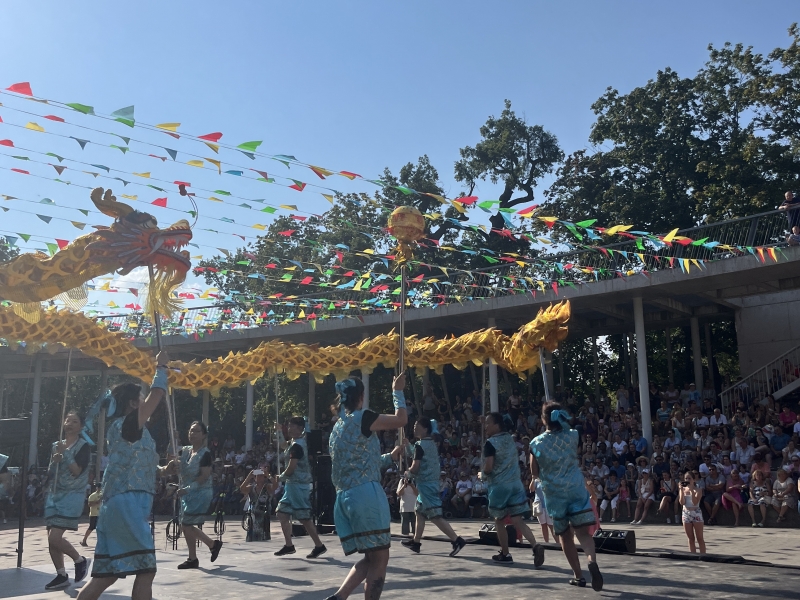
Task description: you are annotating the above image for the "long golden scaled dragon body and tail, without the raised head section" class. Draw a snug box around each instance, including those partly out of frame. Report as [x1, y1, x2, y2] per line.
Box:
[0, 301, 570, 390]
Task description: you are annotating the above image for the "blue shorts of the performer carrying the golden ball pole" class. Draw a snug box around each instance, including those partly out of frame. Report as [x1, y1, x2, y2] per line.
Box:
[333, 481, 391, 555]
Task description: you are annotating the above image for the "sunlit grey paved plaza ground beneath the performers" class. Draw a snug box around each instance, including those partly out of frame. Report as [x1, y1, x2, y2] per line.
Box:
[0, 519, 800, 600]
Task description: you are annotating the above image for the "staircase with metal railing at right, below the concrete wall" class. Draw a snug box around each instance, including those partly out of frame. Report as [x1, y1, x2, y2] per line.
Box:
[720, 346, 800, 415]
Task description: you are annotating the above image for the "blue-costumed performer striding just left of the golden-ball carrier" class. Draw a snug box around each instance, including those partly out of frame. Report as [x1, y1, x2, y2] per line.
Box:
[275, 417, 328, 558]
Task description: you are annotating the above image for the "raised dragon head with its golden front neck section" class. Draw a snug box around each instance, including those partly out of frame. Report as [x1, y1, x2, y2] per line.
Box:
[0, 188, 192, 312]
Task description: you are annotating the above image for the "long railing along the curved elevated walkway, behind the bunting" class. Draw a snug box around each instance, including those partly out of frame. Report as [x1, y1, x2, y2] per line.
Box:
[95, 210, 800, 338]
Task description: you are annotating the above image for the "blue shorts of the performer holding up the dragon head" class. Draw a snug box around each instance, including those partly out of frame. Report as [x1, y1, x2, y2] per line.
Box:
[92, 492, 156, 577]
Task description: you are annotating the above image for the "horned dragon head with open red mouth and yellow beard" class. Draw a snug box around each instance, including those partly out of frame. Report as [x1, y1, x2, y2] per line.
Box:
[86, 188, 192, 313]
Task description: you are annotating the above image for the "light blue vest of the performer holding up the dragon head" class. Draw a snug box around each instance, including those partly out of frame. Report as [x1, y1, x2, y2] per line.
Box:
[103, 418, 158, 500]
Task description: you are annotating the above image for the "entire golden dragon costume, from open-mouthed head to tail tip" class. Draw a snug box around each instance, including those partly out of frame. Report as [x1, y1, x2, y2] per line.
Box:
[0, 188, 570, 392]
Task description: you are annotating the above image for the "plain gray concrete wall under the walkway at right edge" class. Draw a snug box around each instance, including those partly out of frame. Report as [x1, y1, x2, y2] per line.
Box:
[736, 290, 800, 376]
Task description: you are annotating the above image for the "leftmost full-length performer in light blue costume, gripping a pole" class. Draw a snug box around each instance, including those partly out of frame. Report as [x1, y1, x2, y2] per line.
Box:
[44, 412, 91, 590]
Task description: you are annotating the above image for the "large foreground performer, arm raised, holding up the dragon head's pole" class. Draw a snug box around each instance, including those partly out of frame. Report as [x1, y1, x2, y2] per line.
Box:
[78, 351, 175, 600]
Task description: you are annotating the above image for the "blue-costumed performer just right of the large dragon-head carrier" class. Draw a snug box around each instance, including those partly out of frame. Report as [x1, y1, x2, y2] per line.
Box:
[178, 421, 222, 569]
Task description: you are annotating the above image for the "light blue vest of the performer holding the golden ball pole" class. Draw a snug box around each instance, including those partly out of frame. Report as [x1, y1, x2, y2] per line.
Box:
[328, 409, 381, 492]
